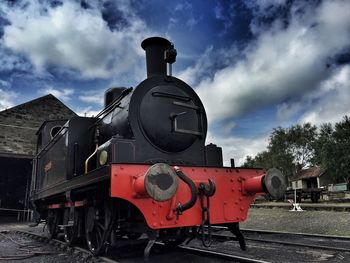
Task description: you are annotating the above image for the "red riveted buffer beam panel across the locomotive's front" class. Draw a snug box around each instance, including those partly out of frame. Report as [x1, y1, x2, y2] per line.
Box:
[111, 164, 263, 229]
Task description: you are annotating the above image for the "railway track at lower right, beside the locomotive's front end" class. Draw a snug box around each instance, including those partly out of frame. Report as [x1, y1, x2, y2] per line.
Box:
[183, 227, 350, 262]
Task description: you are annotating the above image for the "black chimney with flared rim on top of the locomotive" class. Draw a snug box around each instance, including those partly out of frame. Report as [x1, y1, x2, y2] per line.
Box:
[141, 37, 176, 78]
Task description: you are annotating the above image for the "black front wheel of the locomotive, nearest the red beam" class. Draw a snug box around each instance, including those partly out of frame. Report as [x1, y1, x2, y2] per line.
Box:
[85, 201, 113, 256]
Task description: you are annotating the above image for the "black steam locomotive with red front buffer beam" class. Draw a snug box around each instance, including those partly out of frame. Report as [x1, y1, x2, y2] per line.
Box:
[30, 37, 285, 258]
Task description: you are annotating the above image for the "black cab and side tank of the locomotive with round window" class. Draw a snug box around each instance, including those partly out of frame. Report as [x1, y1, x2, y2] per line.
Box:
[32, 117, 97, 196]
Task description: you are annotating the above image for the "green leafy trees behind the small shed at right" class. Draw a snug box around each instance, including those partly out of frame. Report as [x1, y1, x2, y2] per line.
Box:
[243, 116, 350, 182]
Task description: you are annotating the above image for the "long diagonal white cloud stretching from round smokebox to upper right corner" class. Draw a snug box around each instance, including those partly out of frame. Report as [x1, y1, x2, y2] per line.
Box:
[190, 1, 350, 124]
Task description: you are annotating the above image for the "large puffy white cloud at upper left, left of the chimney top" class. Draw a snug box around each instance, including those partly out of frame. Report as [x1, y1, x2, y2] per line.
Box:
[3, 1, 150, 78]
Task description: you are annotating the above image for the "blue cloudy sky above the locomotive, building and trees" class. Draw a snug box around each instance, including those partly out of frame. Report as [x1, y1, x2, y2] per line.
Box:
[0, 0, 350, 165]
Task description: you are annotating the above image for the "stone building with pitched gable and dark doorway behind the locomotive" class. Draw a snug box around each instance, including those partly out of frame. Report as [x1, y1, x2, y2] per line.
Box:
[0, 94, 76, 219]
